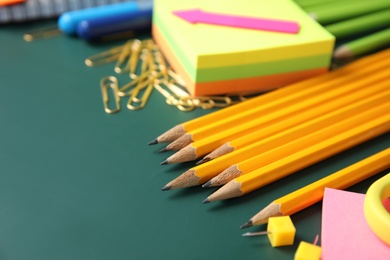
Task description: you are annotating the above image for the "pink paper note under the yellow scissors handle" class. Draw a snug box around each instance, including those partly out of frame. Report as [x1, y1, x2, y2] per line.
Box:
[321, 188, 390, 260]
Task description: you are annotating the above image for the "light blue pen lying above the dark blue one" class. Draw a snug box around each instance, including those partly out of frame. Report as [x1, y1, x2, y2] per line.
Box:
[58, 1, 153, 35]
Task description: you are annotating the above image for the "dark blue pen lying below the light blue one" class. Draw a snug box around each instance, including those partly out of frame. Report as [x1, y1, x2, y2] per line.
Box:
[76, 2, 153, 40]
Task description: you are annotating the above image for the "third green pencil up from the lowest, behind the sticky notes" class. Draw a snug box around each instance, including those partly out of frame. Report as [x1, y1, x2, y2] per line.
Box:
[306, 0, 390, 25]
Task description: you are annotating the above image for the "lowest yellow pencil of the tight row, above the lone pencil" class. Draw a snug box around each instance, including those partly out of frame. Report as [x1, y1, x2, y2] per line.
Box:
[204, 104, 390, 203]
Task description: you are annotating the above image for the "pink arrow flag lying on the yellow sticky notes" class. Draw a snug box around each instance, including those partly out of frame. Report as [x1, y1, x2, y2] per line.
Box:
[173, 9, 299, 34]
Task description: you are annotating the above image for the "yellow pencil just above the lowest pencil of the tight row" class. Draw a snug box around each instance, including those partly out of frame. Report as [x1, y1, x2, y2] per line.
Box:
[203, 87, 390, 187]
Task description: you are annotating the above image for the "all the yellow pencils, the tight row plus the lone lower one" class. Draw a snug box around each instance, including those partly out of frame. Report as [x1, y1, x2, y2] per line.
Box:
[150, 49, 390, 227]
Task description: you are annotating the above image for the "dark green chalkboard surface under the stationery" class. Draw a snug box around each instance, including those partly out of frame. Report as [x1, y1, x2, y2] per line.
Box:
[0, 20, 390, 260]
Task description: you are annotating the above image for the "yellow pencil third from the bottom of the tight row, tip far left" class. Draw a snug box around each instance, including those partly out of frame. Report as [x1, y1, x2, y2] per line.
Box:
[163, 88, 390, 190]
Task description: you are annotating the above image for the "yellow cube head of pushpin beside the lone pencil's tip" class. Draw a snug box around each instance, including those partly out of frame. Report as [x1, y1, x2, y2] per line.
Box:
[267, 216, 295, 247]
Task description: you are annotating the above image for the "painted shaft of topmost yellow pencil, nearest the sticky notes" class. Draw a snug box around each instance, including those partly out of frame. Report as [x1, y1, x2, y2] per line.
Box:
[158, 50, 390, 136]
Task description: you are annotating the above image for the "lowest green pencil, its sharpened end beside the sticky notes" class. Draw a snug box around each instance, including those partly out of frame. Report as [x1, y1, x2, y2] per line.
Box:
[334, 27, 390, 58]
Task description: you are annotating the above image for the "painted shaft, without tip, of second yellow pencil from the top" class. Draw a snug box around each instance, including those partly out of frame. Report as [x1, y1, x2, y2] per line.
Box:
[180, 54, 390, 141]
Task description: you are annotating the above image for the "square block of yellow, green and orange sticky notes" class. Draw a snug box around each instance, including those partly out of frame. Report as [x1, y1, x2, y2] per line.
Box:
[153, 0, 335, 96]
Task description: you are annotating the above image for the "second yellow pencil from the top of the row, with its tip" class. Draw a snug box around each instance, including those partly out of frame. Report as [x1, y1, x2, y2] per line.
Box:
[161, 54, 390, 152]
